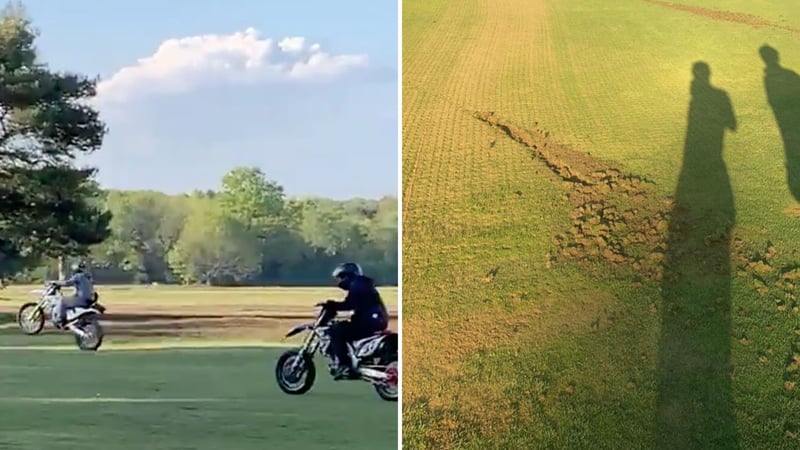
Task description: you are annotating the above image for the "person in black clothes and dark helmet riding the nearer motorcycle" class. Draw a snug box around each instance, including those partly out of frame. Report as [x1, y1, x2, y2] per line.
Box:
[325, 262, 389, 380]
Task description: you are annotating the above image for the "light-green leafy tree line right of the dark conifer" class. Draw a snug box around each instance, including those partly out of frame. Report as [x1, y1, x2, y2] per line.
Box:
[89, 171, 397, 285]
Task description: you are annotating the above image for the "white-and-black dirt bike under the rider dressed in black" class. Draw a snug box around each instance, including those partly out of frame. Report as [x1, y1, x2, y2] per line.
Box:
[275, 303, 399, 402]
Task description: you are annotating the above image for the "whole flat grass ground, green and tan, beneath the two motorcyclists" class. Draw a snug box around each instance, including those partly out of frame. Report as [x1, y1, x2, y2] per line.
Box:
[0, 286, 397, 450]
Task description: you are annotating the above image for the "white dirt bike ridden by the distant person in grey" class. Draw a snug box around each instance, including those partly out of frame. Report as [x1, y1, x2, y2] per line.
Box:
[17, 284, 106, 351]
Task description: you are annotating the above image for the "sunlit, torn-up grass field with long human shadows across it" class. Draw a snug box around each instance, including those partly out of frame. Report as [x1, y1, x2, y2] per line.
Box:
[403, 0, 800, 449]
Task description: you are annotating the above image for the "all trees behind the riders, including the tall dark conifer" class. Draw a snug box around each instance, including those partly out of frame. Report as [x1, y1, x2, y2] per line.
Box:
[0, 6, 398, 285]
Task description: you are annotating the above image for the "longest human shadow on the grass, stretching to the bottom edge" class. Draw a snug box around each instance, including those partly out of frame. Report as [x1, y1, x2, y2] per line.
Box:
[656, 62, 738, 449]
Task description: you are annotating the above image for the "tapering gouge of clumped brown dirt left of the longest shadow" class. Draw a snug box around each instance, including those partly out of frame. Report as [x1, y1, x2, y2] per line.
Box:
[475, 112, 673, 280]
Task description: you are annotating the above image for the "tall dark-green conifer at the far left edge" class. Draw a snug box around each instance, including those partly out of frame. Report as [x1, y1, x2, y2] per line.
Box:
[0, 6, 111, 275]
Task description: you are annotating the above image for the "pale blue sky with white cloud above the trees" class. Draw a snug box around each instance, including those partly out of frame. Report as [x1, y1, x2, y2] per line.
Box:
[24, 0, 399, 198]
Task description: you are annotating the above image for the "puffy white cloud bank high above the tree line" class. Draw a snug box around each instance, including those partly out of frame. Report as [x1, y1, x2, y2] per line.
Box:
[96, 28, 368, 104]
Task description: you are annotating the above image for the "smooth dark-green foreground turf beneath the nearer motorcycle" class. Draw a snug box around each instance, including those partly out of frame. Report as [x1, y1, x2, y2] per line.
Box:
[0, 348, 397, 450]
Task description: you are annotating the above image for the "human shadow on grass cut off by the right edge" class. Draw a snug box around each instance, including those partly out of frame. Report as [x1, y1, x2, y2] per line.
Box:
[758, 45, 800, 201]
